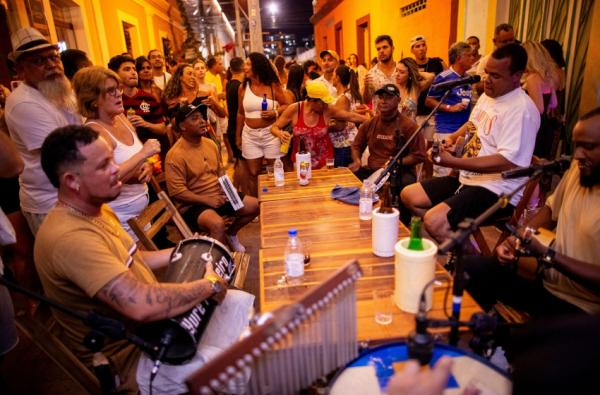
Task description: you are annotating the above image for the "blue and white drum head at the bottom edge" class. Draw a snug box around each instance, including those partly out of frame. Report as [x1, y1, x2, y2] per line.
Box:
[329, 342, 512, 395]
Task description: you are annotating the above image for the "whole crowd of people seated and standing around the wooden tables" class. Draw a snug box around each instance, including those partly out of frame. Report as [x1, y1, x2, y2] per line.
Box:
[0, 20, 600, 393]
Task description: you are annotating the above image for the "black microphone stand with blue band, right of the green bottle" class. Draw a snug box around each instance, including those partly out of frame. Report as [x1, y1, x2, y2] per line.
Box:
[438, 170, 543, 346]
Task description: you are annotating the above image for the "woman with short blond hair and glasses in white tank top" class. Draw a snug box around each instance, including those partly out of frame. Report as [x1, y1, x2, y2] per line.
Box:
[73, 67, 160, 241]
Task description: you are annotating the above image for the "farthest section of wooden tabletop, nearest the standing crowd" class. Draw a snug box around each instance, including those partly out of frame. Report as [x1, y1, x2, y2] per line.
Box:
[258, 167, 361, 203]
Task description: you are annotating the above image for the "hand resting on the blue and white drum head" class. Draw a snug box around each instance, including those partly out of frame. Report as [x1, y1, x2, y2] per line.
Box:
[387, 357, 452, 395]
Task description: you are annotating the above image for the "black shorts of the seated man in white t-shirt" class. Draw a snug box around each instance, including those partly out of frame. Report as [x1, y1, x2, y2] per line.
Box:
[421, 176, 514, 230]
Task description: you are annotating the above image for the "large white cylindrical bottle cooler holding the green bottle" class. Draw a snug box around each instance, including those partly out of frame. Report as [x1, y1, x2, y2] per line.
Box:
[394, 237, 437, 313]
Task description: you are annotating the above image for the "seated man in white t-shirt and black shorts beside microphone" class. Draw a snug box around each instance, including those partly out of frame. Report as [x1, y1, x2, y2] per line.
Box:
[401, 44, 540, 242]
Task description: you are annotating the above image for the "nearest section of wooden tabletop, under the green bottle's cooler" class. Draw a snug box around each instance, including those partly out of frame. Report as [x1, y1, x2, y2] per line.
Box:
[259, 244, 481, 342]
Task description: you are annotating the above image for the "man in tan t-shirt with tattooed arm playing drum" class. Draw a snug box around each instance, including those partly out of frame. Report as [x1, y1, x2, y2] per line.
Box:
[35, 125, 252, 393]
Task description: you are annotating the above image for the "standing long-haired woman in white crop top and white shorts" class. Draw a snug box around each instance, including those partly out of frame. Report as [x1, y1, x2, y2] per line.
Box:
[236, 52, 291, 196]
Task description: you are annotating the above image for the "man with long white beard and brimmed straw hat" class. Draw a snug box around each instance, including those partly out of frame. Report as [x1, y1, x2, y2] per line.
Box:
[5, 27, 81, 235]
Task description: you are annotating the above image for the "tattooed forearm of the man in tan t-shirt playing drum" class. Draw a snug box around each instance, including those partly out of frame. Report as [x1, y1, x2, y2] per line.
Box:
[96, 267, 227, 322]
